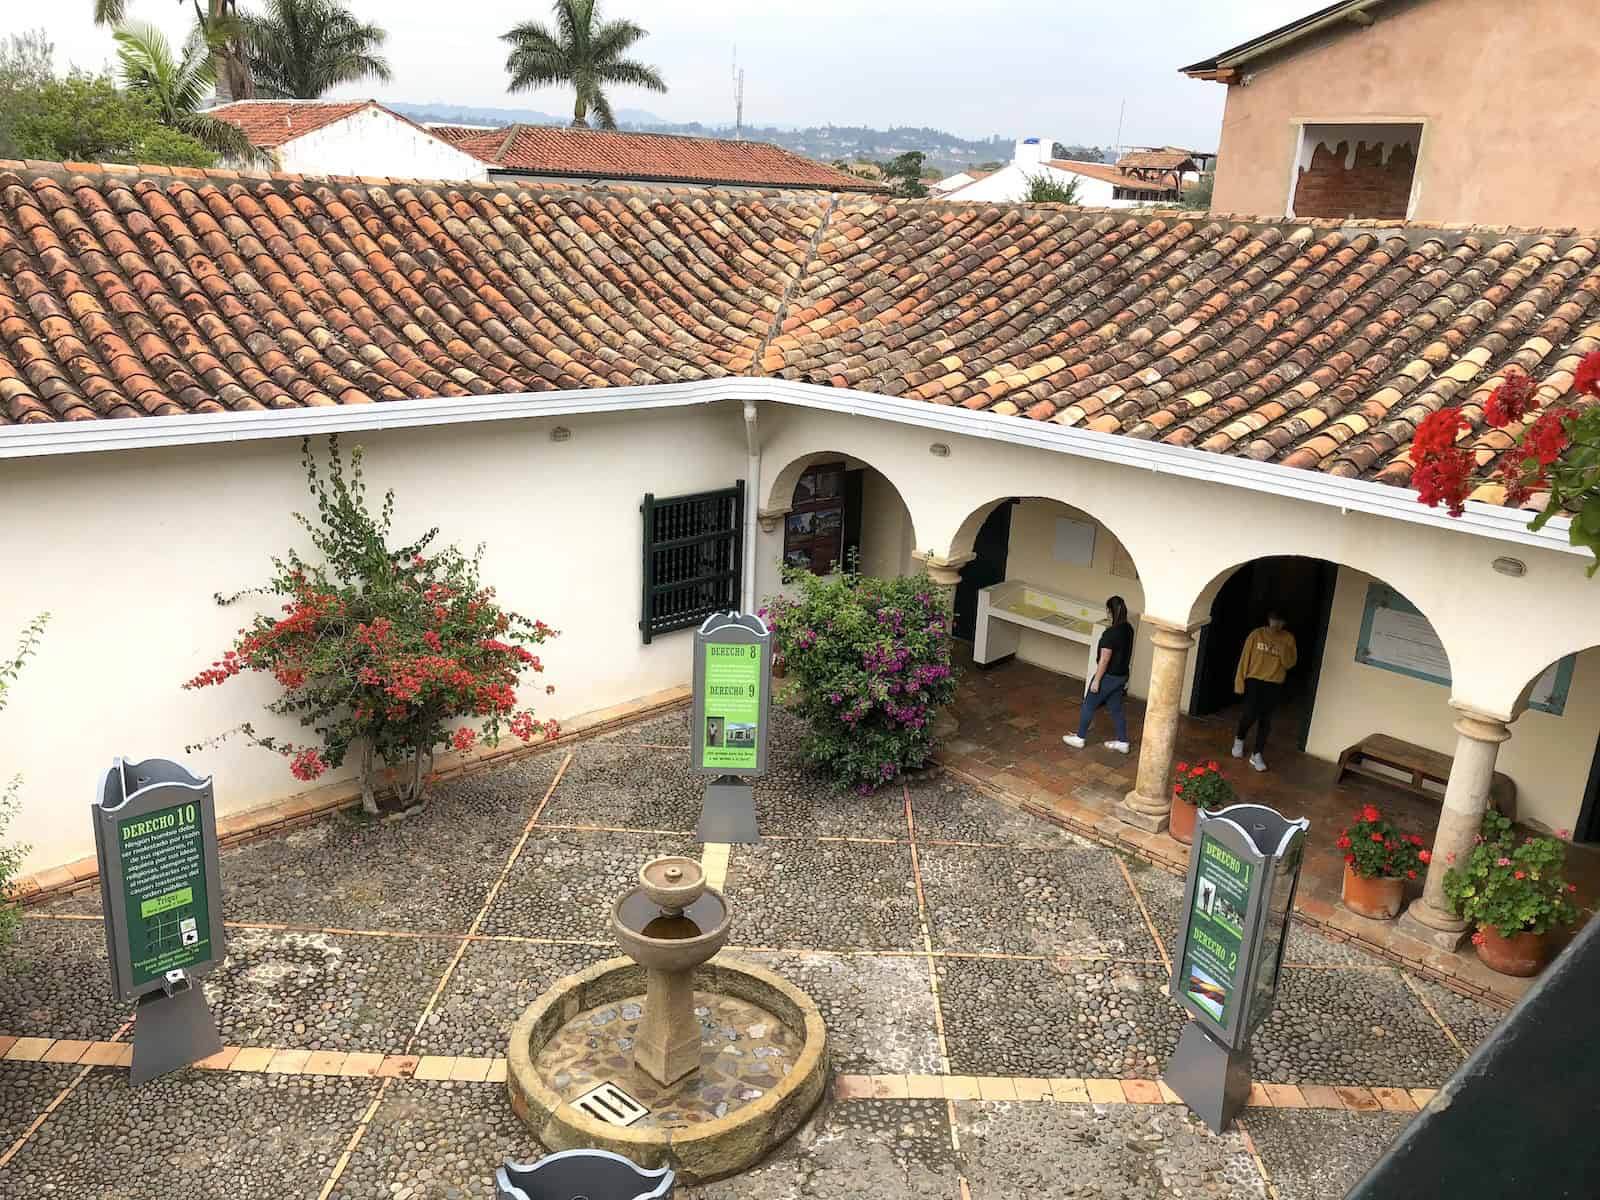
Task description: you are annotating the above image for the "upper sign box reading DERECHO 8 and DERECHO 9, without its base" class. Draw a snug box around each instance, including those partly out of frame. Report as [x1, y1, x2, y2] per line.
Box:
[690, 613, 773, 774]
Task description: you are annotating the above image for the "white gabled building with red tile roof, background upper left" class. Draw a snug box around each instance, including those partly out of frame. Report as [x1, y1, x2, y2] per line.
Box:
[208, 99, 488, 179]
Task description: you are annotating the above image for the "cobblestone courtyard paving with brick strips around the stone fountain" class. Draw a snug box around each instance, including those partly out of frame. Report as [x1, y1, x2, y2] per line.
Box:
[0, 712, 1501, 1200]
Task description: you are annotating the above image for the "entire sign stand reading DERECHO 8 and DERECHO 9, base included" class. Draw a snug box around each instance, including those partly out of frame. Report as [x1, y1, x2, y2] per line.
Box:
[690, 613, 773, 842]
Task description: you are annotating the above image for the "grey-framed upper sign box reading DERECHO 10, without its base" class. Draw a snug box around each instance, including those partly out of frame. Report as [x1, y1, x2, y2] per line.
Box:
[94, 758, 227, 1000]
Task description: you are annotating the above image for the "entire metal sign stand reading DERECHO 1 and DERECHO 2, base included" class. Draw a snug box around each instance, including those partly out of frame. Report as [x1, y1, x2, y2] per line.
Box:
[1162, 805, 1310, 1133]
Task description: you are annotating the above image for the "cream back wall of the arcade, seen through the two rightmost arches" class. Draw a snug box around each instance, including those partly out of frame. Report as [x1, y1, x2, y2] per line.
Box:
[1306, 570, 1600, 830]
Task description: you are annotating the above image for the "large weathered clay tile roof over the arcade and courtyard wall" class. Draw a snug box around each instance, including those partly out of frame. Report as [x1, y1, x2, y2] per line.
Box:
[0, 162, 1600, 512]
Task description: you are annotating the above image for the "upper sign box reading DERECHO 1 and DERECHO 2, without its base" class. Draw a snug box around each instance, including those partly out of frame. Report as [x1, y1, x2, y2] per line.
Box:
[1173, 805, 1306, 1048]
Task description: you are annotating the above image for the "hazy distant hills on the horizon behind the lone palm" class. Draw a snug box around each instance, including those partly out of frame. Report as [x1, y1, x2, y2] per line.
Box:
[389, 104, 1036, 173]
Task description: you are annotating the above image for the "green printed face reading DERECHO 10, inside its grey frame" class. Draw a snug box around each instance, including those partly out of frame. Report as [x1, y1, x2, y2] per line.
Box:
[117, 802, 213, 987]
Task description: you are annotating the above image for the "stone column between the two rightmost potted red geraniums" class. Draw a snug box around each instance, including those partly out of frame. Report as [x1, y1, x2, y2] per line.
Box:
[1400, 713, 1510, 950]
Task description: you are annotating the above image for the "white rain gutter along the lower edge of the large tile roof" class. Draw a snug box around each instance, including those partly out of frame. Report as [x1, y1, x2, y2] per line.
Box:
[0, 376, 1589, 555]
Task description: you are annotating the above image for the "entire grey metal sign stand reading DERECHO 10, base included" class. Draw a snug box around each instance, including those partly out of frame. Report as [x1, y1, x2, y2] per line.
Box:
[93, 758, 227, 1086]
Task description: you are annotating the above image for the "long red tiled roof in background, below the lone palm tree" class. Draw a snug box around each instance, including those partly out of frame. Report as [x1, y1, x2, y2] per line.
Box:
[429, 125, 885, 192]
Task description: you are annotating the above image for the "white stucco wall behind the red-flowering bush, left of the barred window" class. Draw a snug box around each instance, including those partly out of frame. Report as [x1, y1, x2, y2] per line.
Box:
[0, 406, 746, 867]
